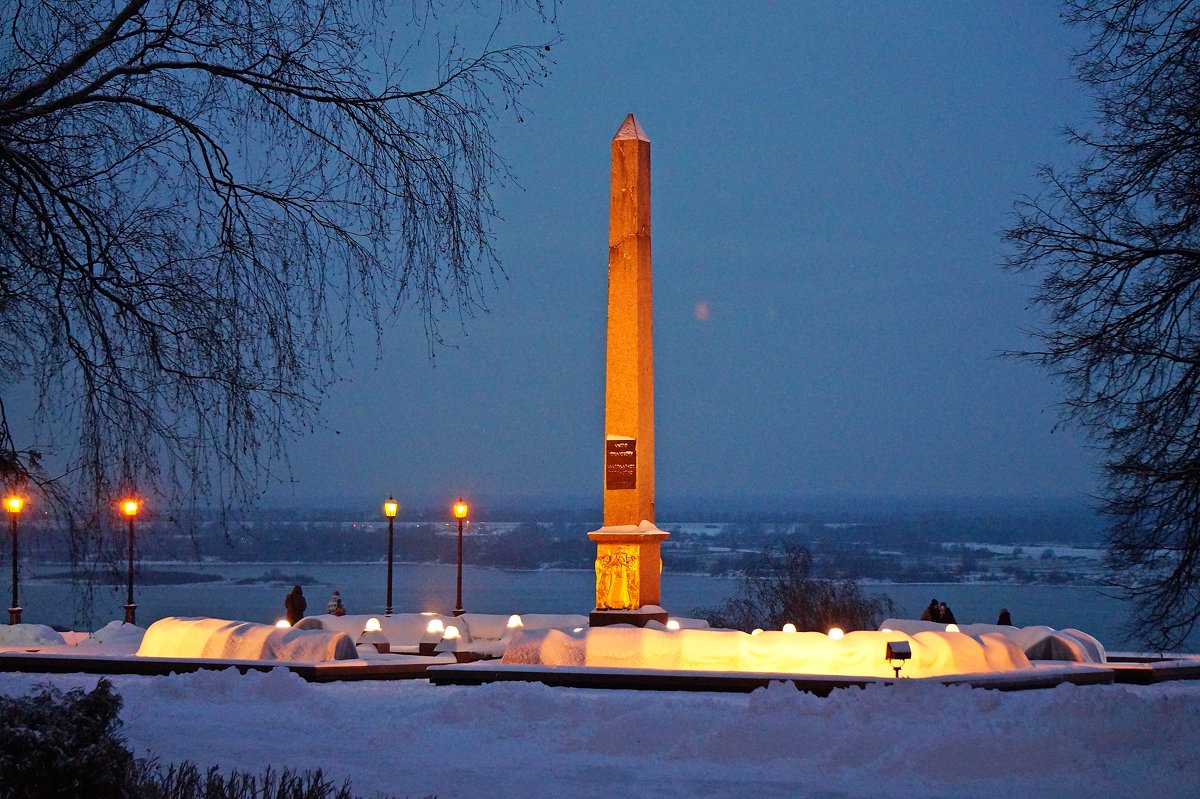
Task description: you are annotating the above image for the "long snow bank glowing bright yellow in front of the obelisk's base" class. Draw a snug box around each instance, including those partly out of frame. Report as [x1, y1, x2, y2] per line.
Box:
[503, 625, 1031, 678]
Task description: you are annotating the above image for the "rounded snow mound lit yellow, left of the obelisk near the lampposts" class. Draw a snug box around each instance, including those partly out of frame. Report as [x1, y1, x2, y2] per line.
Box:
[137, 617, 358, 663]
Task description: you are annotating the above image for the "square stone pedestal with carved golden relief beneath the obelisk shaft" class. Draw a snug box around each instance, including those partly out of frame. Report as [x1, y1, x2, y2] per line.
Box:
[588, 522, 668, 627]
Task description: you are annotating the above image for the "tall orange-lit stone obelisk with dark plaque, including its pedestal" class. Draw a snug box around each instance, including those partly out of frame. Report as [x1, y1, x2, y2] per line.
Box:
[588, 114, 667, 626]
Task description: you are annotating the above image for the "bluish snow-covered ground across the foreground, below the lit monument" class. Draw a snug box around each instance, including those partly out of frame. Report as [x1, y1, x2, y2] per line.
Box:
[0, 669, 1200, 799]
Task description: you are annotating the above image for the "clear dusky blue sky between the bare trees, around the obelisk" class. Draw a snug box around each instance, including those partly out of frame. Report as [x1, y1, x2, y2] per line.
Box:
[265, 1, 1096, 506]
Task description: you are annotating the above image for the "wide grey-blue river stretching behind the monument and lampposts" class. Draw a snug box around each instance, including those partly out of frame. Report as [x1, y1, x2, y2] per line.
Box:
[11, 563, 1198, 651]
